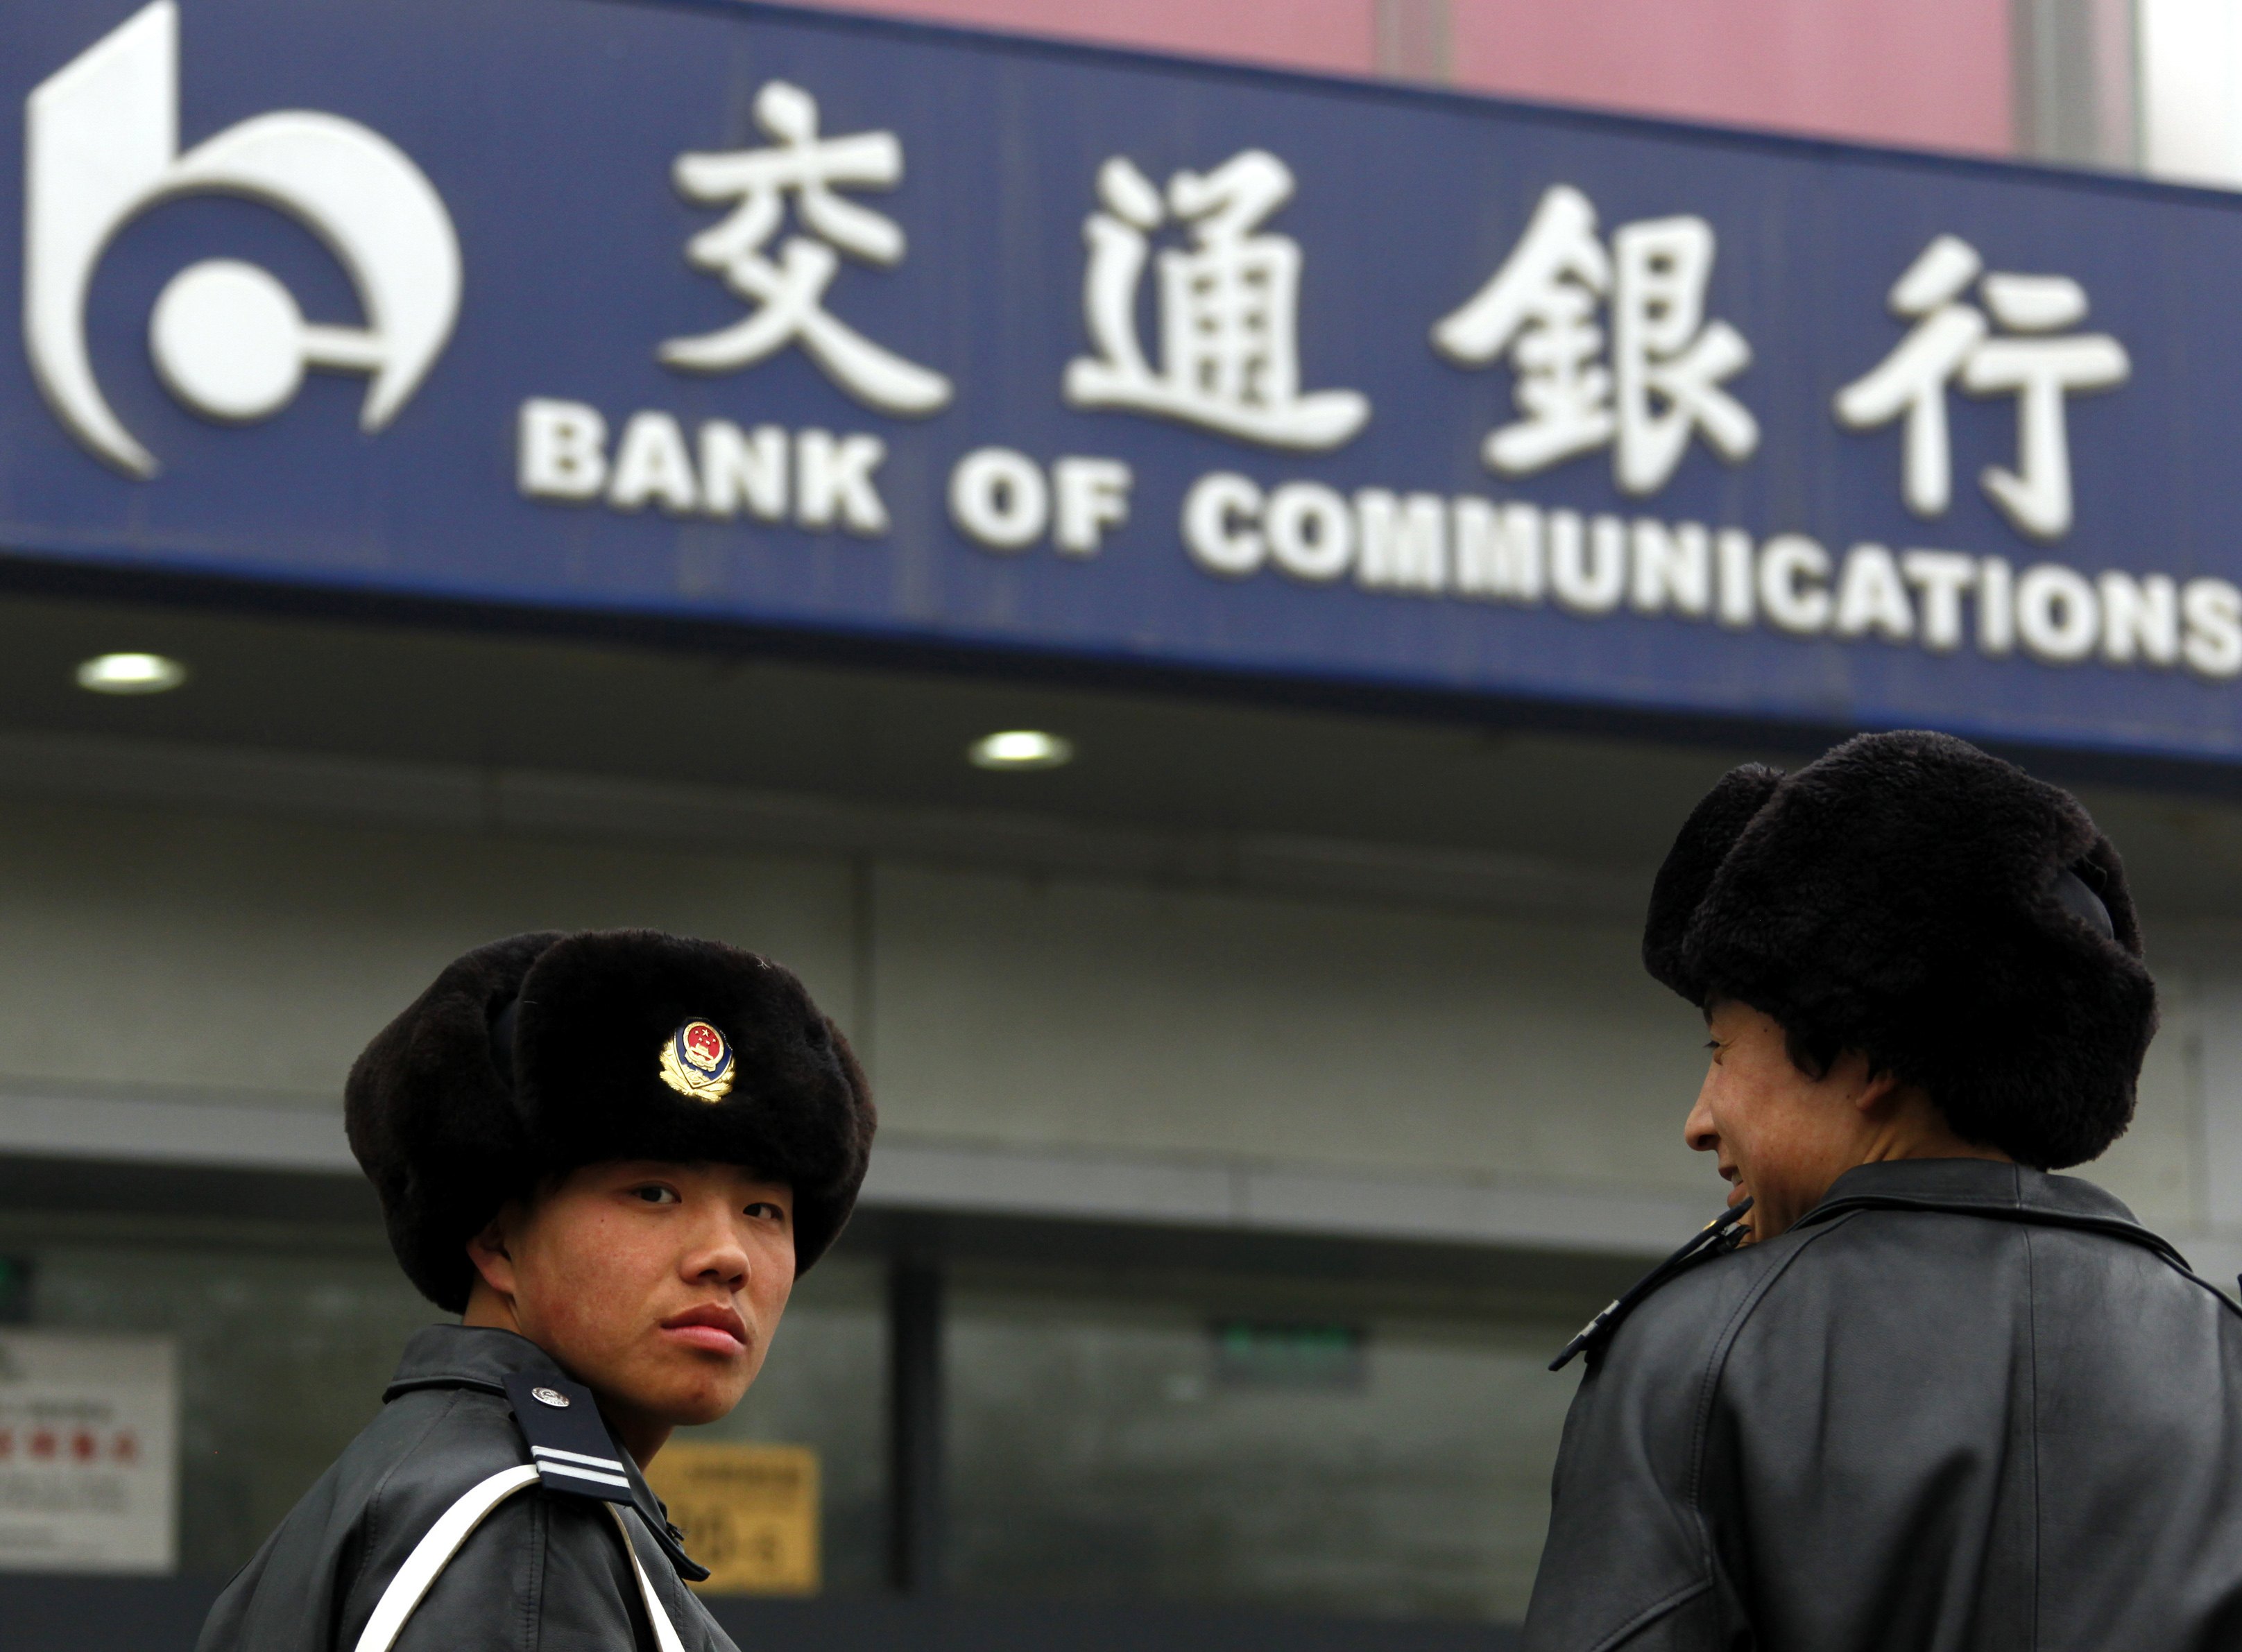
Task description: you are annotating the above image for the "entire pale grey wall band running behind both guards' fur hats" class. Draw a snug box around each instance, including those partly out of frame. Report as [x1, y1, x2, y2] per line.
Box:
[0, 740, 2215, 1271]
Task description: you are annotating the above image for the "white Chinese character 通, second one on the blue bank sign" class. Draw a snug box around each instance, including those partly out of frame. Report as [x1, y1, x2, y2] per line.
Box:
[1065, 150, 1370, 451]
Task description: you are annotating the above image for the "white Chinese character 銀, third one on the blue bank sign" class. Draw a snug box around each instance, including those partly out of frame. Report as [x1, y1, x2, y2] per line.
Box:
[1432, 184, 1760, 495]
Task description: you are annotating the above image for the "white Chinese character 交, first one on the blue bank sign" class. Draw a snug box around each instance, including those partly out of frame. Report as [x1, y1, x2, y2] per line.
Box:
[659, 80, 950, 415]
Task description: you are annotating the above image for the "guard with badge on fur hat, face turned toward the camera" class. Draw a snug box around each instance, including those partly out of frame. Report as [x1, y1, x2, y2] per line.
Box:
[200, 930, 874, 1652]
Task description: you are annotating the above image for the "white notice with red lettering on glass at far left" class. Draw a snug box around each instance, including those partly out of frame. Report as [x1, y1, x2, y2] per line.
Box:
[0, 1332, 180, 1572]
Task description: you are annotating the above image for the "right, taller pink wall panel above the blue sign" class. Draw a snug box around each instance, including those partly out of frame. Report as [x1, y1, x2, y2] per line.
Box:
[1448, 0, 2013, 155]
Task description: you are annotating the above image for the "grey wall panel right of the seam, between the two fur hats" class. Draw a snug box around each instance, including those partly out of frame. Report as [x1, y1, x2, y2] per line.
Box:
[872, 868, 1706, 1192]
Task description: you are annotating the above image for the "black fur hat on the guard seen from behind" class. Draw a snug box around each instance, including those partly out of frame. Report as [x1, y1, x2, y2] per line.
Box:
[1643, 731, 2157, 1170]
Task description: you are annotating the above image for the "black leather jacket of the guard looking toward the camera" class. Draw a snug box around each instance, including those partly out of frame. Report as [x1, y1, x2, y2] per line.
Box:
[195, 1325, 735, 1652]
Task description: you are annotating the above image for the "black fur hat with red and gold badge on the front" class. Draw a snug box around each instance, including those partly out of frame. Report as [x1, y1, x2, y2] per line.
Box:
[343, 930, 874, 1314]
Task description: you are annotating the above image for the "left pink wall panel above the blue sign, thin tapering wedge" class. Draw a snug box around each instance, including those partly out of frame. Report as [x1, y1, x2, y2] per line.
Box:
[789, 0, 1376, 74]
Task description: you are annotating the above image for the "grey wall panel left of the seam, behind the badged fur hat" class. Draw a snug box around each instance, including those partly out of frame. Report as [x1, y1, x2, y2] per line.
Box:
[0, 802, 850, 1110]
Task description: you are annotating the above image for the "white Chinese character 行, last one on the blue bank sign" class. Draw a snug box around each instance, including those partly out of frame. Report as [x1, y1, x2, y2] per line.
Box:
[1836, 235, 2132, 540]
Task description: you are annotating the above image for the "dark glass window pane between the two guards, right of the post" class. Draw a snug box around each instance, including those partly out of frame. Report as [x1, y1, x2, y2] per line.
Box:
[946, 1268, 1585, 1621]
